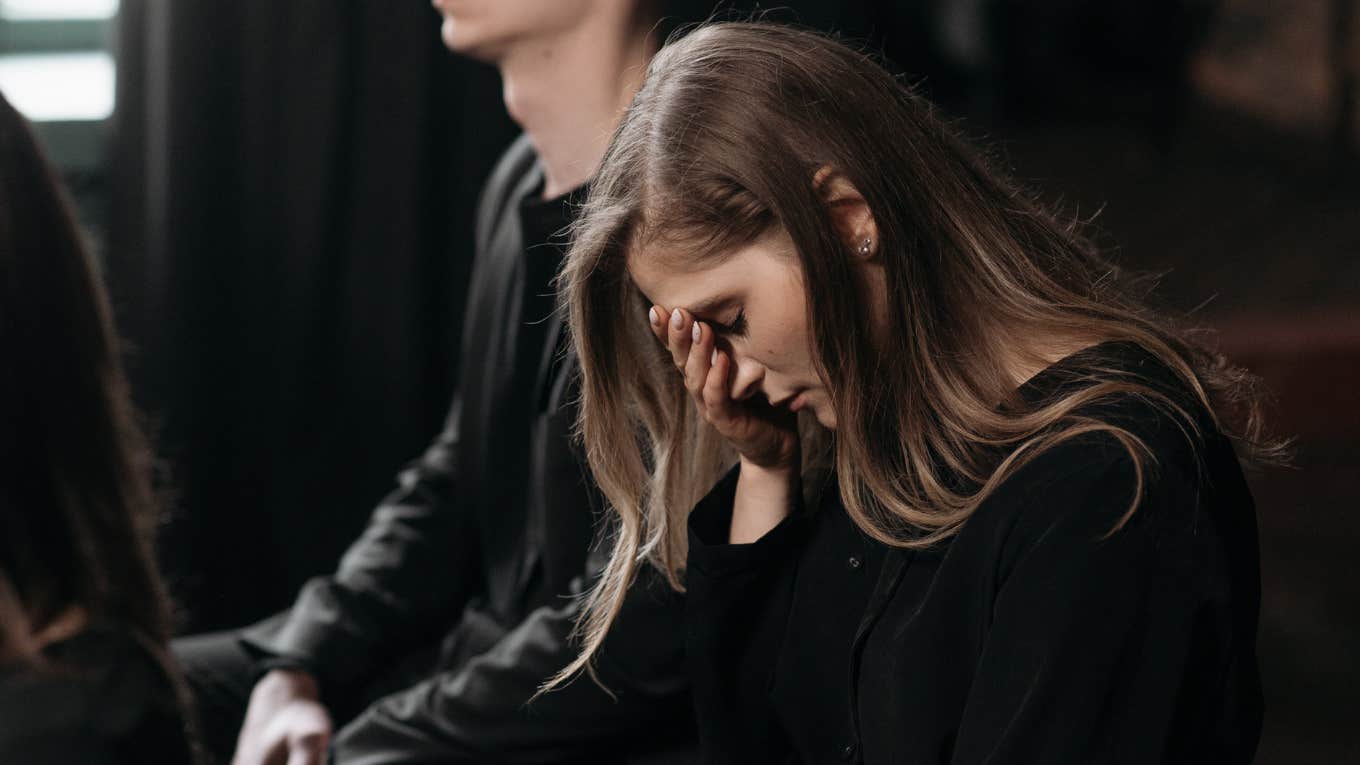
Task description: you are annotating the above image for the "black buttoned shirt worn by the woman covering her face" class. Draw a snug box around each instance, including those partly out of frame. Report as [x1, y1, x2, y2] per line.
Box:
[685, 343, 1262, 765]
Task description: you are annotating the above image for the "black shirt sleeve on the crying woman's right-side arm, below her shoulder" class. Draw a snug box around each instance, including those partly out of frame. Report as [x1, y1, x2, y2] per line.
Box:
[952, 441, 1250, 765]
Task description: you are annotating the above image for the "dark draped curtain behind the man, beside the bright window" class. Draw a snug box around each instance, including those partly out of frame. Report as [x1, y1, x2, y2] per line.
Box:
[107, 0, 514, 630]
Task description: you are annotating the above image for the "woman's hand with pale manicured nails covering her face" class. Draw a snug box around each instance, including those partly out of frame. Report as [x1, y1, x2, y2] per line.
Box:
[649, 306, 800, 471]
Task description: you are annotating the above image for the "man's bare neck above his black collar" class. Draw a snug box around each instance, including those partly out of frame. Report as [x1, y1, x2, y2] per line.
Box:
[500, 15, 656, 199]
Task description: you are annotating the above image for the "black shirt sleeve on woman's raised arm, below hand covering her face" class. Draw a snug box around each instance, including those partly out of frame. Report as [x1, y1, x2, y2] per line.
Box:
[685, 468, 806, 764]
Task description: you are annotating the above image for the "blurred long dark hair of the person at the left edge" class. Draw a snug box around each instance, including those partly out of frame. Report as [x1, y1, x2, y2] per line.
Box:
[0, 90, 170, 648]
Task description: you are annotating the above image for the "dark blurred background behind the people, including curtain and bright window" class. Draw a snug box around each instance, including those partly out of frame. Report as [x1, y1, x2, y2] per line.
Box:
[0, 0, 1360, 764]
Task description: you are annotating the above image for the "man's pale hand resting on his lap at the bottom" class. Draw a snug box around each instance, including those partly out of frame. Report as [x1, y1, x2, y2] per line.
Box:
[231, 670, 332, 765]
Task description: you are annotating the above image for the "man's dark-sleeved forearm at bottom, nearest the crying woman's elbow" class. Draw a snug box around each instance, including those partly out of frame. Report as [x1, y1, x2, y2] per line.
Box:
[326, 566, 692, 765]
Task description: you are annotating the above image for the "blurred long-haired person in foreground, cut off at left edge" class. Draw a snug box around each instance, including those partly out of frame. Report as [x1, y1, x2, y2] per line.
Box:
[0, 97, 193, 764]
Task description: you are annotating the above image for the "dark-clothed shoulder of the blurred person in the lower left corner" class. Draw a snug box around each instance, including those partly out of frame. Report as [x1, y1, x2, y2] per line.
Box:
[0, 625, 193, 764]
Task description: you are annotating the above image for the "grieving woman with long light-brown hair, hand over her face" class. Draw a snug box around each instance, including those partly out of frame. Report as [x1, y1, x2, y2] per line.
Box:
[555, 25, 1281, 764]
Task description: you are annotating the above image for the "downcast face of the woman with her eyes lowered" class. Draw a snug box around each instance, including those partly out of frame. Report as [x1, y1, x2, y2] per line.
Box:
[627, 227, 836, 429]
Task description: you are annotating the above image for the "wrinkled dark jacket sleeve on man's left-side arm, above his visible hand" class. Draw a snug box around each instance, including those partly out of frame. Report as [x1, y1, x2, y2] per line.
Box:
[242, 400, 479, 694]
